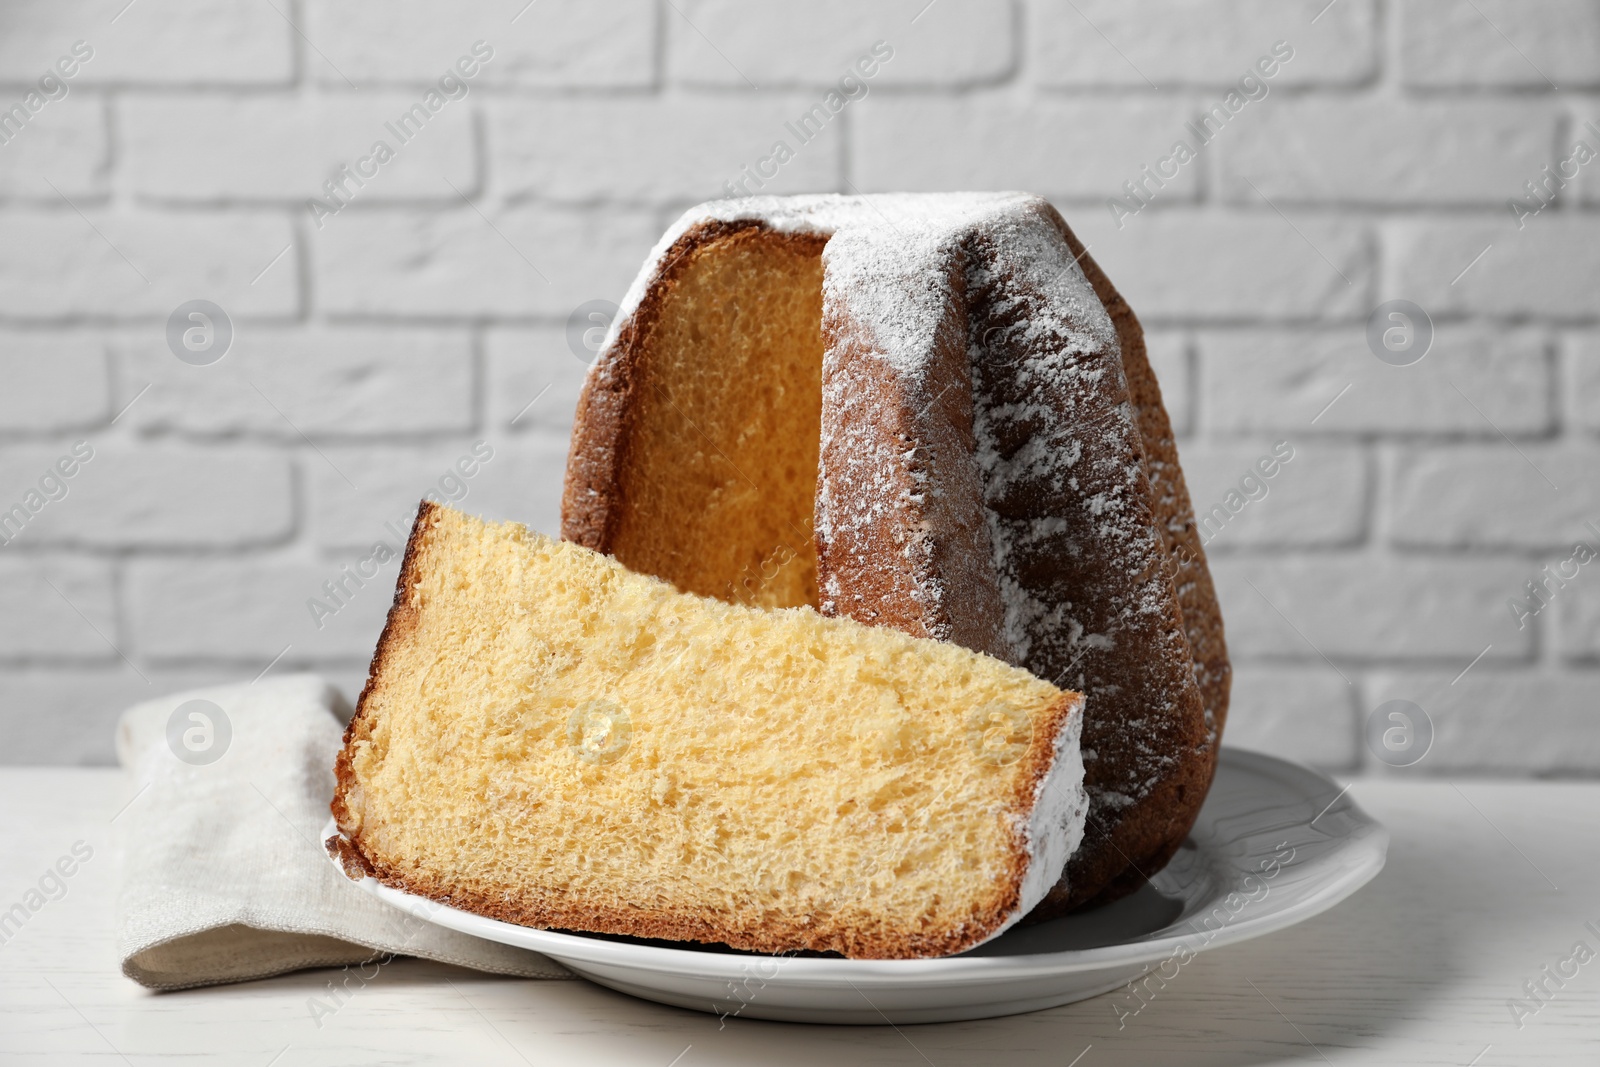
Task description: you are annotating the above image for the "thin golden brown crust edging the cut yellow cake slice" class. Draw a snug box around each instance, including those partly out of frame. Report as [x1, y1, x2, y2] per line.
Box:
[325, 501, 1083, 960]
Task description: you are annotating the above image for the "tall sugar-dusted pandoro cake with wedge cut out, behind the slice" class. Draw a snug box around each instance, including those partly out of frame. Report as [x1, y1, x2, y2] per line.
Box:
[562, 194, 1229, 918]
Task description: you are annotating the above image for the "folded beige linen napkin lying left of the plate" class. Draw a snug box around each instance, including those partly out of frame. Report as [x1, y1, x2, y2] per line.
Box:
[117, 673, 573, 989]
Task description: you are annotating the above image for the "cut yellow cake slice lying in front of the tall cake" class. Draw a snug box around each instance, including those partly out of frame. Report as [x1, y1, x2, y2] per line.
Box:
[328, 502, 1088, 958]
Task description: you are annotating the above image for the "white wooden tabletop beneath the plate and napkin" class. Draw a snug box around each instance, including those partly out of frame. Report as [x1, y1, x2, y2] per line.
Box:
[0, 768, 1600, 1067]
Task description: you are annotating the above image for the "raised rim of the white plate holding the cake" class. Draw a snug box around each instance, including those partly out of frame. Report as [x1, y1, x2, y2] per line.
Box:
[320, 745, 1389, 987]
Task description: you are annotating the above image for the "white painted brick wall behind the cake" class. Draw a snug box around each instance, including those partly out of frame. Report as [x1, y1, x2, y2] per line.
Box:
[0, 0, 1600, 776]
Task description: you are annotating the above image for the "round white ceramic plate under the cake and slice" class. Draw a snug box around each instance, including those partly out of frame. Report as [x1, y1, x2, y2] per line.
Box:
[323, 749, 1389, 1024]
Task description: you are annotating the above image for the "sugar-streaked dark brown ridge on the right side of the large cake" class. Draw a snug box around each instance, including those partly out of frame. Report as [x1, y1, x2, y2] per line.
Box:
[966, 202, 1187, 819]
